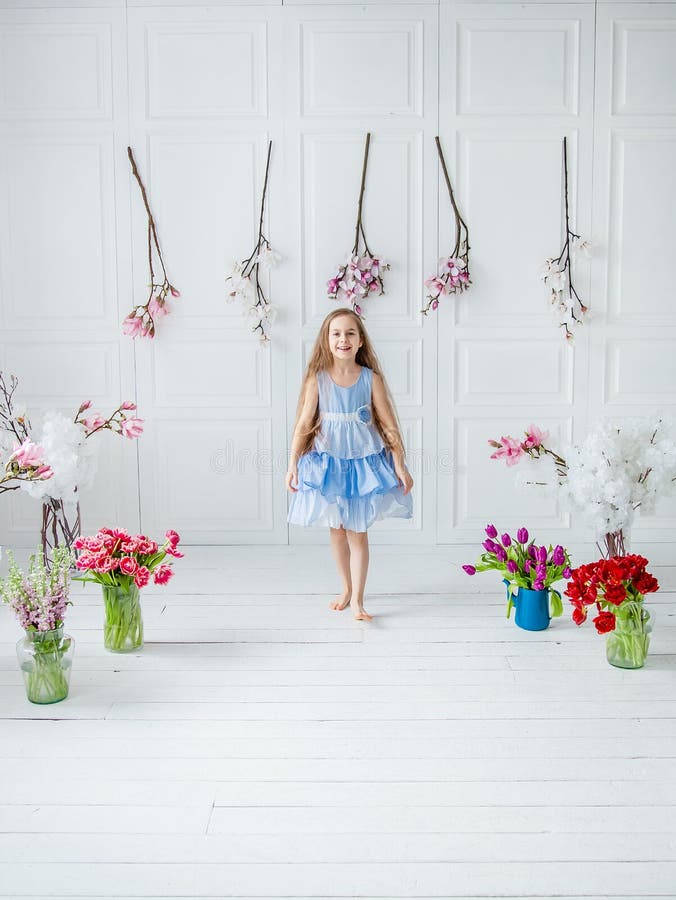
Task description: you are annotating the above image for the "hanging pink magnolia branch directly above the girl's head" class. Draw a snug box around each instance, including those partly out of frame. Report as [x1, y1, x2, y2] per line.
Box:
[326, 132, 390, 316]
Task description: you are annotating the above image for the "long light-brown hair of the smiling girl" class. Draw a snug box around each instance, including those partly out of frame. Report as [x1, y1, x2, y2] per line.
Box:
[294, 308, 403, 455]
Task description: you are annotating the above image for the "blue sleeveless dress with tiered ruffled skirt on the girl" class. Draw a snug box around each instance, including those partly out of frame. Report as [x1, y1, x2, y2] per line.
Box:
[288, 366, 413, 531]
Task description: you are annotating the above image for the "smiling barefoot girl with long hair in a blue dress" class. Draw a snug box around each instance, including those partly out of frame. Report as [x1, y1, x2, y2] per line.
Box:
[286, 309, 413, 620]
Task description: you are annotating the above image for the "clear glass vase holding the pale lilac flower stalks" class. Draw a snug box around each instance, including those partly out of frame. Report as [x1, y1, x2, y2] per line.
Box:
[16, 626, 73, 703]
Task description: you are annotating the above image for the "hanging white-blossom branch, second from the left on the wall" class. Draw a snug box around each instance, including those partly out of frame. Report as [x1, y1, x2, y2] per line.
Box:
[225, 141, 282, 344]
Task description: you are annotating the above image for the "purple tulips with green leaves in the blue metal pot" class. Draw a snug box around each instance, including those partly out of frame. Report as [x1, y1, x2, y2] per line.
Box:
[463, 525, 572, 617]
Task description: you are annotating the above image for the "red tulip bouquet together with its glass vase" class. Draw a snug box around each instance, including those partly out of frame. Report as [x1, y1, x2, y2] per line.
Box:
[565, 555, 660, 669]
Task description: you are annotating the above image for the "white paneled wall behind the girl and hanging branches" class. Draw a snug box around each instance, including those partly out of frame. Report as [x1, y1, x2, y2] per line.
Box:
[0, 0, 676, 545]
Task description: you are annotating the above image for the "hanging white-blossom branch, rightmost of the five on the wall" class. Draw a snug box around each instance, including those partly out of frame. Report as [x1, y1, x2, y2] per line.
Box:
[540, 137, 592, 341]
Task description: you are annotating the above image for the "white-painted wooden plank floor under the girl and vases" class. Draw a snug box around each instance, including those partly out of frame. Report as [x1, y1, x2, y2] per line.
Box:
[0, 547, 676, 900]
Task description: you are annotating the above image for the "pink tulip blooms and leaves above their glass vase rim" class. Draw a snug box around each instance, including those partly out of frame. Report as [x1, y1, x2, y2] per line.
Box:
[73, 528, 183, 588]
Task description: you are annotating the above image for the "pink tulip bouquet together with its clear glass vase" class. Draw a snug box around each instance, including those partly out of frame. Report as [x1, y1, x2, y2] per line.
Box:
[73, 528, 183, 653]
